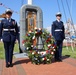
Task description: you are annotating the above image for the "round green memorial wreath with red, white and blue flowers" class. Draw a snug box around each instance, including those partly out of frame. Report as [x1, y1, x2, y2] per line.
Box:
[22, 28, 57, 64]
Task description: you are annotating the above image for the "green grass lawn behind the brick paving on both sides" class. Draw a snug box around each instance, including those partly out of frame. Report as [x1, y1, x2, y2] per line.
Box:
[0, 42, 76, 59]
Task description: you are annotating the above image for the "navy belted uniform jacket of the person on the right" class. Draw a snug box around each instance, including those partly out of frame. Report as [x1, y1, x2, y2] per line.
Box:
[52, 20, 65, 41]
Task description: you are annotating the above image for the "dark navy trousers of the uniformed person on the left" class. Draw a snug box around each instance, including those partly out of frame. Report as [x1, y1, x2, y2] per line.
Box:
[3, 41, 15, 64]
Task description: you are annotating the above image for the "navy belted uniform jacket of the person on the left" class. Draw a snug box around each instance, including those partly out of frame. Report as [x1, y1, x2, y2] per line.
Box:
[0, 19, 19, 42]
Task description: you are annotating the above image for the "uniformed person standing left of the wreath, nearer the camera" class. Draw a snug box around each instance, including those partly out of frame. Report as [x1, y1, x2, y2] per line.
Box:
[0, 9, 19, 68]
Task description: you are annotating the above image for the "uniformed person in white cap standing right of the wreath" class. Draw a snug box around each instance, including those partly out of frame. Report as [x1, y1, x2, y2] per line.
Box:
[51, 12, 65, 62]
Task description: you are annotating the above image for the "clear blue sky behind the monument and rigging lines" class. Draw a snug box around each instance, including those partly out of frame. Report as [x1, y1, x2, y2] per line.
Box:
[0, 0, 76, 28]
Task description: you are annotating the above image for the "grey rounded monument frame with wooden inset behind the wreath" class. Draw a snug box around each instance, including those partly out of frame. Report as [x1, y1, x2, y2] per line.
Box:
[20, 0, 43, 51]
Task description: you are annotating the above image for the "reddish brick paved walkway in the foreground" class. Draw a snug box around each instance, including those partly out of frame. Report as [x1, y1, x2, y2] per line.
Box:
[0, 57, 76, 75]
